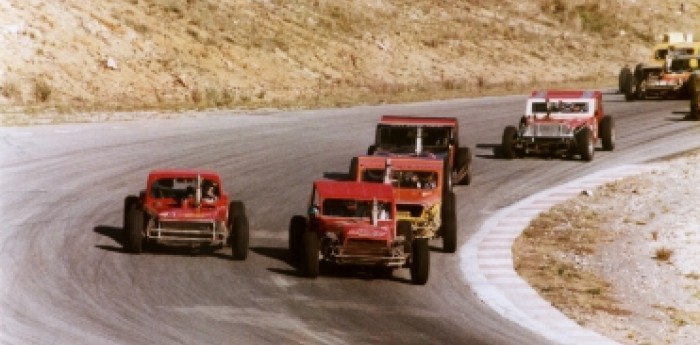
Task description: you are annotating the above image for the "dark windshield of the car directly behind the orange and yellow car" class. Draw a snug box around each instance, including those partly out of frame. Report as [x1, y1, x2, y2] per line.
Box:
[377, 125, 452, 153]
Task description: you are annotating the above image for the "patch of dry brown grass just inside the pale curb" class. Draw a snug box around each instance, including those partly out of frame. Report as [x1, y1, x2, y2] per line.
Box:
[513, 192, 628, 322]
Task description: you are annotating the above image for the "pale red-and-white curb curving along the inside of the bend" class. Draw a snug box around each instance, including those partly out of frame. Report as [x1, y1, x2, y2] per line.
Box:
[459, 164, 654, 345]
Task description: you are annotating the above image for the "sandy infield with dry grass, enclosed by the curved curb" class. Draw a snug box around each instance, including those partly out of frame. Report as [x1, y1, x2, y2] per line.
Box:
[513, 152, 700, 344]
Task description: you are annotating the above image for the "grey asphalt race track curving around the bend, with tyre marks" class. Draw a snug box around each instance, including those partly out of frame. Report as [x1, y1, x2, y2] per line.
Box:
[0, 92, 700, 345]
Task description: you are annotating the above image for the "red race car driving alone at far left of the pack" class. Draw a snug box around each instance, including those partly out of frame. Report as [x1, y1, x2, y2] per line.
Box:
[124, 169, 249, 260]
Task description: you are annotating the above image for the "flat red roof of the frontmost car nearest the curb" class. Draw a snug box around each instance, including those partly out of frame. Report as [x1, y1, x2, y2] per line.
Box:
[314, 180, 394, 201]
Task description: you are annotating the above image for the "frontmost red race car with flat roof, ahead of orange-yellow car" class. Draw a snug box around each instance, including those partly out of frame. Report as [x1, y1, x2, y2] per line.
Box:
[289, 180, 430, 285]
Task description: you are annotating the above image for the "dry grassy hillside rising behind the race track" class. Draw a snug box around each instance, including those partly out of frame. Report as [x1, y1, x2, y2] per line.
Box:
[0, 0, 700, 112]
